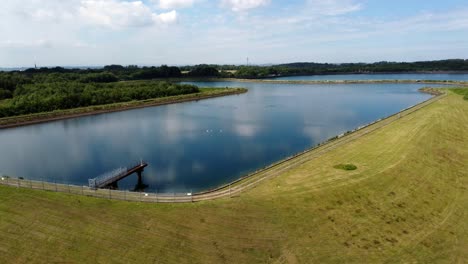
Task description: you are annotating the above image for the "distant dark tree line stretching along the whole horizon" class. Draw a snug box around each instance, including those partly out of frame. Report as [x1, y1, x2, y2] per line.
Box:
[0, 59, 468, 89]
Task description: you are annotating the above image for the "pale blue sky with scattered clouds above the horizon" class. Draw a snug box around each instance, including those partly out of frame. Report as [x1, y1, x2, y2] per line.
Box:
[0, 0, 468, 67]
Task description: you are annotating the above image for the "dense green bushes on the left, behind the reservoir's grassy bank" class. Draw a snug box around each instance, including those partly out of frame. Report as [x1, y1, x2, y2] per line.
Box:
[0, 81, 199, 117]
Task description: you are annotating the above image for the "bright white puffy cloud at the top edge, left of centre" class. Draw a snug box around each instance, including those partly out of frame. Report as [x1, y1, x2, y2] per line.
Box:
[79, 0, 177, 28]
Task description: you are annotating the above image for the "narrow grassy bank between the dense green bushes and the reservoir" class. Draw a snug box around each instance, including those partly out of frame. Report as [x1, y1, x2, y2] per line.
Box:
[0, 88, 247, 129]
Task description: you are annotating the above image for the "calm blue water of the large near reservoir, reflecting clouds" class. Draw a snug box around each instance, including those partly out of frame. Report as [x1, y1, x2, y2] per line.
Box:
[0, 82, 429, 192]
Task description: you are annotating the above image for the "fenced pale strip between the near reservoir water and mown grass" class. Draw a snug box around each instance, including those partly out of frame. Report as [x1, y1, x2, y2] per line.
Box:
[0, 94, 446, 203]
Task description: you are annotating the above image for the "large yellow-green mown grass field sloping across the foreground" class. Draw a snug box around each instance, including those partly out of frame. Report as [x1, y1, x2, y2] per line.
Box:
[0, 92, 468, 263]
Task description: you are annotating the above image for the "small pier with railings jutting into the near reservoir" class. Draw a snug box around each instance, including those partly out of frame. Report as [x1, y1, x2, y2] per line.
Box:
[88, 161, 148, 189]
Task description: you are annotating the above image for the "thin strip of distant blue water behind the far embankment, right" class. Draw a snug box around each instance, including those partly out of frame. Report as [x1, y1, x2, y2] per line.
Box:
[271, 73, 468, 81]
